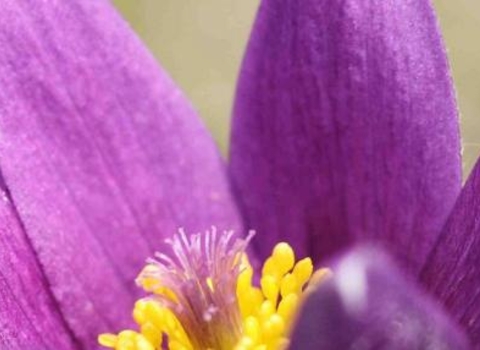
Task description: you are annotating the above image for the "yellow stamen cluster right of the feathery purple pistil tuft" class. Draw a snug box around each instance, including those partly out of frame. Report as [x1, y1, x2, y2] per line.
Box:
[234, 243, 330, 350]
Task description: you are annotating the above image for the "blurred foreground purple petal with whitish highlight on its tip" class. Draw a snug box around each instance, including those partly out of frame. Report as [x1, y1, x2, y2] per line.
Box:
[291, 249, 469, 350]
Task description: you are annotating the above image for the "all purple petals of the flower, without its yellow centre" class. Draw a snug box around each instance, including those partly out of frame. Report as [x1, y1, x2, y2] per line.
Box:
[0, 0, 480, 349]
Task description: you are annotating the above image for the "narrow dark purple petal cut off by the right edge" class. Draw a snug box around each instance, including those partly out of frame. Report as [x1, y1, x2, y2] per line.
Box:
[421, 157, 480, 347]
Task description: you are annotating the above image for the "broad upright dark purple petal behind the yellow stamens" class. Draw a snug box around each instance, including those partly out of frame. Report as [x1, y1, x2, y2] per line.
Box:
[230, 0, 461, 272]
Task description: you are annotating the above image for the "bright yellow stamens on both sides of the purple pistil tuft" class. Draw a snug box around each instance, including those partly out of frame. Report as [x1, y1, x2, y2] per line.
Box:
[98, 231, 330, 350]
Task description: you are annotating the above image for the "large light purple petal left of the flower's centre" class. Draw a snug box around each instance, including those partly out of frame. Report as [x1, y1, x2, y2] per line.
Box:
[0, 0, 238, 348]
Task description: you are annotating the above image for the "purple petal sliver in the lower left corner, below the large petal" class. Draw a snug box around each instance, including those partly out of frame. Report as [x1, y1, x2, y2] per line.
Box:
[0, 180, 76, 350]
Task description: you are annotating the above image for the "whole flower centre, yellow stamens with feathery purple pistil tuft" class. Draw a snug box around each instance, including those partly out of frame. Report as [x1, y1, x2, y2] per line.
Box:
[98, 228, 330, 350]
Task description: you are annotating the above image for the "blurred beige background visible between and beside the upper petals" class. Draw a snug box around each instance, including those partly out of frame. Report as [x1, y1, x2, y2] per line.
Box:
[114, 0, 480, 175]
